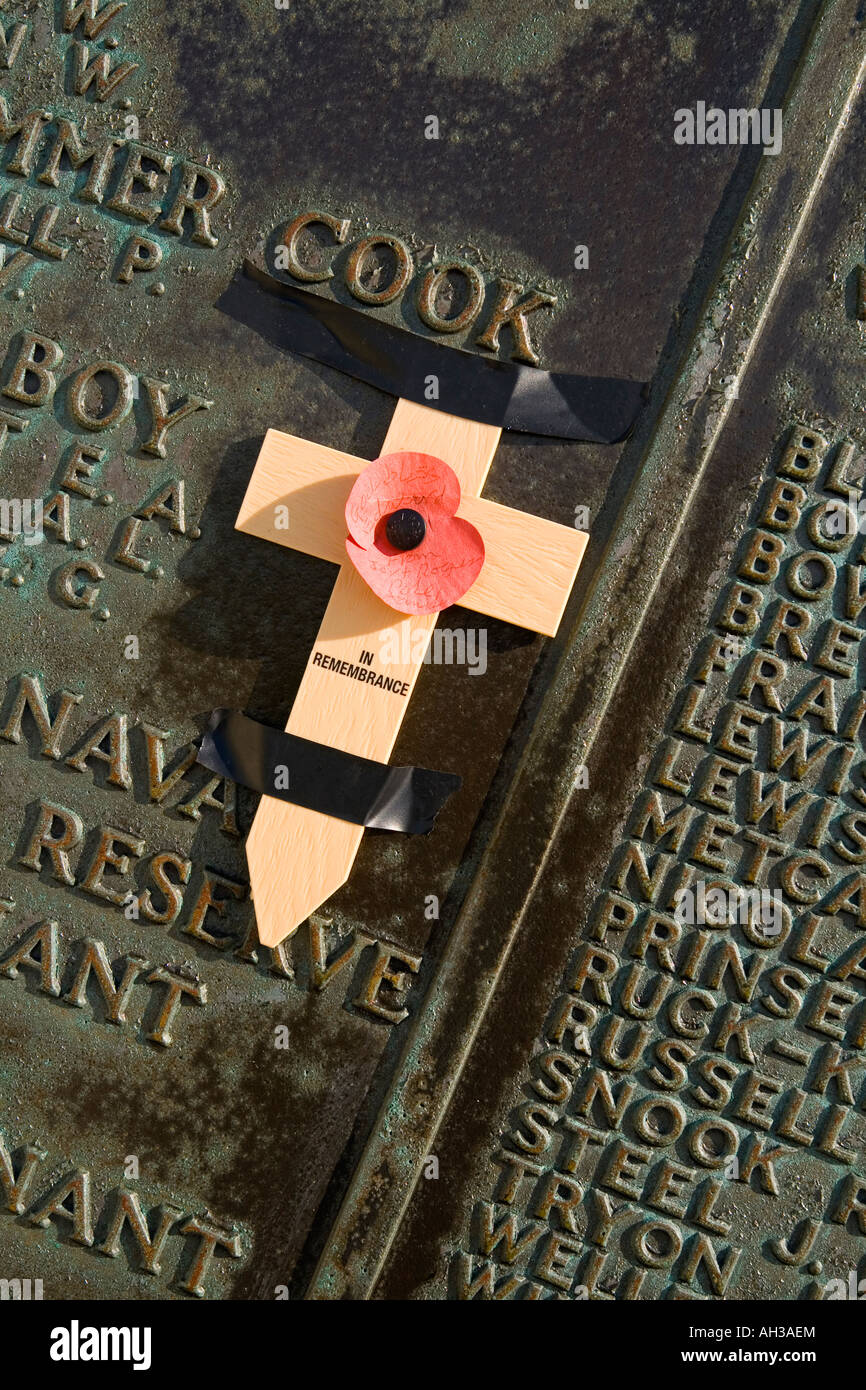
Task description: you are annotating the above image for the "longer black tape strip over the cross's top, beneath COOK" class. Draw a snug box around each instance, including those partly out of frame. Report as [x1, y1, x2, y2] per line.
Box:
[217, 261, 644, 443]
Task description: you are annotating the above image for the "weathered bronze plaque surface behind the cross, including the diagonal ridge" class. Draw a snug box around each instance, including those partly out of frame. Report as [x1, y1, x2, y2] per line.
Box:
[0, 0, 862, 1298]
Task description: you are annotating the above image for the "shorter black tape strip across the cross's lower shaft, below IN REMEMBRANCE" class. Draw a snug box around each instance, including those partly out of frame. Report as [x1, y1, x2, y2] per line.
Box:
[197, 709, 461, 835]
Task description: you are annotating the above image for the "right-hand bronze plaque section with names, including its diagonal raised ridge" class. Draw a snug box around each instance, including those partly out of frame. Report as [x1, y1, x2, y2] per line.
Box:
[323, 6, 866, 1298]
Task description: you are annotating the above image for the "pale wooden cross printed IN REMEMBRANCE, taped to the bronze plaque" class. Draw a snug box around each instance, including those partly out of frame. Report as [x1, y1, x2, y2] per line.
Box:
[235, 400, 588, 947]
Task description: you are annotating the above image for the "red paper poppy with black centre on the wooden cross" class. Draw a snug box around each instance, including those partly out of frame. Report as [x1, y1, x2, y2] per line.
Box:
[346, 453, 484, 613]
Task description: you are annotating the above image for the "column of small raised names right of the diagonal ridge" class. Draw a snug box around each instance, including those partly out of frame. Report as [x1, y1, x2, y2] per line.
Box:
[450, 425, 866, 1298]
